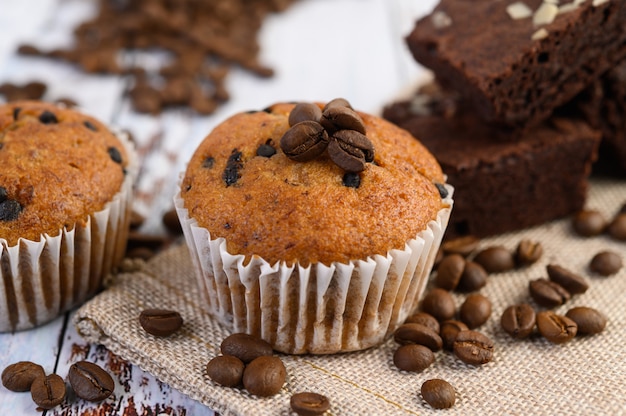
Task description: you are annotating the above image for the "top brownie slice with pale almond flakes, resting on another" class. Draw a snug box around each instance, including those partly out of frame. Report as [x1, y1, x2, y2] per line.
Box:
[407, 0, 626, 126]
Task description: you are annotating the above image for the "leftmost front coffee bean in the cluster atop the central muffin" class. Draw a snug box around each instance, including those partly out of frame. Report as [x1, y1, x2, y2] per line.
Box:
[280, 121, 329, 162]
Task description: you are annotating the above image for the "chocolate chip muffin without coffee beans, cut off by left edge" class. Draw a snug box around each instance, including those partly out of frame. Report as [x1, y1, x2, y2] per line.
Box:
[0, 101, 135, 331]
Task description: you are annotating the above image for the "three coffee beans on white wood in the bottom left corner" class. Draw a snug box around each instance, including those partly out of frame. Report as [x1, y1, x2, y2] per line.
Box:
[2, 361, 115, 409]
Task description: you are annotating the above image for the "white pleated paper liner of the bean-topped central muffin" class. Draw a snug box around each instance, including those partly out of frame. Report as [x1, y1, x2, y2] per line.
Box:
[174, 185, 453, 354]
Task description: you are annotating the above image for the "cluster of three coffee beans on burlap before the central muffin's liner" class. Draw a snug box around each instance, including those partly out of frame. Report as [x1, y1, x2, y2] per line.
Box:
[206, 333, 287, 397]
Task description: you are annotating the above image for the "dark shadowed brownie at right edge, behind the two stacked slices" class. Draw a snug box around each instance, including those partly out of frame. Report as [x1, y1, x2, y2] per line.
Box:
[557, 60, 626, 176]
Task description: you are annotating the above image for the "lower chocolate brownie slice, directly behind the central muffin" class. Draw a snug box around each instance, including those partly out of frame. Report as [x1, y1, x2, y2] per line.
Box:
[383, 85, 600, 238]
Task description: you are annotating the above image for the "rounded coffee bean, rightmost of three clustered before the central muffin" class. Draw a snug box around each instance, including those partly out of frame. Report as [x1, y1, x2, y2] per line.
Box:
[243, 356, 287, 397]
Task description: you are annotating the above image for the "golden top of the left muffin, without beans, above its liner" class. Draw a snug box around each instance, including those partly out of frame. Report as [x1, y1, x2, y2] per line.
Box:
[0, 101, 128, 246]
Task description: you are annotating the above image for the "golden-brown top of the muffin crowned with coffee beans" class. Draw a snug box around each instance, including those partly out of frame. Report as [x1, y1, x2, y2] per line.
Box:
[181, 100, 447, 266]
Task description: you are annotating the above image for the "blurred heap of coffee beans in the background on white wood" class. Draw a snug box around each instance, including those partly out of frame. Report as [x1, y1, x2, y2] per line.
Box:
[18, 0, 294, 114]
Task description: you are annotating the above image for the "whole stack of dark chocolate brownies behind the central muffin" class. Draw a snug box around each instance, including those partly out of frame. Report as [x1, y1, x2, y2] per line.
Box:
[384, 0, 626, 238]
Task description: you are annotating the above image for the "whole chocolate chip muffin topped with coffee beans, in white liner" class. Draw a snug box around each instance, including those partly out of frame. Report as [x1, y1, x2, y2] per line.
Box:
[175, 99, 452, 353]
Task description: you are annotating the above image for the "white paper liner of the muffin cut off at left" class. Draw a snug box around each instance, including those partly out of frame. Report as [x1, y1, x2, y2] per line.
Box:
[0, 133, 137, 332]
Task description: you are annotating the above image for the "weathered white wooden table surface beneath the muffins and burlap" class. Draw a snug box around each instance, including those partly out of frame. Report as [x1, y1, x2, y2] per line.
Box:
[0, 0, 436, 416]
